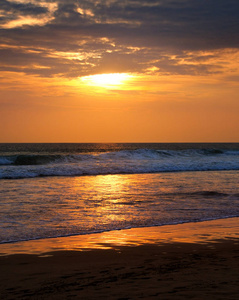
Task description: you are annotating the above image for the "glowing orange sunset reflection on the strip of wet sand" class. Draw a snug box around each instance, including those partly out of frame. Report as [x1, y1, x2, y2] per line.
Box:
[0, 218, 239, 255]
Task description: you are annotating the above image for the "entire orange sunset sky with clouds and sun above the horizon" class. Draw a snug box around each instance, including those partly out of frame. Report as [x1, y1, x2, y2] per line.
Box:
[0, 0, 239, 143]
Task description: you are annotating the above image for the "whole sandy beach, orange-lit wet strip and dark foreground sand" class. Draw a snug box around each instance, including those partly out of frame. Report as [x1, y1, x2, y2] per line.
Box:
[0, 218, 239, 299]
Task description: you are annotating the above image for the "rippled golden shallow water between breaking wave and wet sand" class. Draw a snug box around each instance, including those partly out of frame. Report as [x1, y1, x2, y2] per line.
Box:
[0, 171, 239, 243]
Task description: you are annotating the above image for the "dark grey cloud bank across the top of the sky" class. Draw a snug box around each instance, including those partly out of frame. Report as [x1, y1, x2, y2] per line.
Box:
[0, 0, 239, 77]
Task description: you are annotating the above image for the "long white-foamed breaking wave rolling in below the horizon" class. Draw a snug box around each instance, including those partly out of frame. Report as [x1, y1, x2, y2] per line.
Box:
[0, 149, 239, 179]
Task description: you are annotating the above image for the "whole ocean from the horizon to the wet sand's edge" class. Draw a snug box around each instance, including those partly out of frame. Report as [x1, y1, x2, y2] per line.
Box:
[0, 143, 239, 244]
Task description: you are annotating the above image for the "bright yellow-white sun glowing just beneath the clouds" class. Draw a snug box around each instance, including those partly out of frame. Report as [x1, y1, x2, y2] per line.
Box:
[82, 73, 132, 88]
